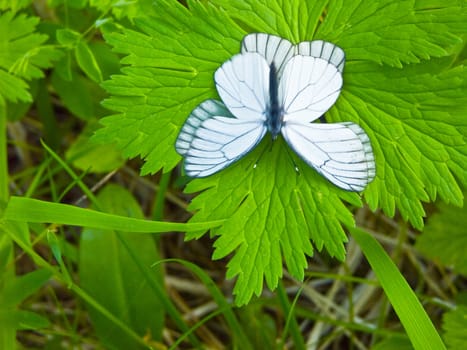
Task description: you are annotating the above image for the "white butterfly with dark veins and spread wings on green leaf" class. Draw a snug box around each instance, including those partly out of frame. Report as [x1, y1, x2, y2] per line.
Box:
[175, 33, 375, 191]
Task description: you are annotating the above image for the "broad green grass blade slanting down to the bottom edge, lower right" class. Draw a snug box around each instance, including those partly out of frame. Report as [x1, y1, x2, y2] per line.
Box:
[349, 228, 446, 350]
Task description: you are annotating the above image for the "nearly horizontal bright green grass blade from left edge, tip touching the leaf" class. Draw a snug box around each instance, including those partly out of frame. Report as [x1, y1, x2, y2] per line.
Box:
[4, 197, 223, 233]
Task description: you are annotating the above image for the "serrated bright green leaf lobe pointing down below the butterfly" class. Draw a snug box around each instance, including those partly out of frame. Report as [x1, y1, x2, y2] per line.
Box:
[186, 140, 361, 304]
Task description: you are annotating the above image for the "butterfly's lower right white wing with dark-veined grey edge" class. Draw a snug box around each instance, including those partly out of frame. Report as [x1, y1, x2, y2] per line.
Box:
[281, 122, 375, 192]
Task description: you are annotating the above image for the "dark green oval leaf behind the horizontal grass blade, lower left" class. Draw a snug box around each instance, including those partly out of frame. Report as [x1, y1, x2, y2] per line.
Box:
[79, 185, 164, 349]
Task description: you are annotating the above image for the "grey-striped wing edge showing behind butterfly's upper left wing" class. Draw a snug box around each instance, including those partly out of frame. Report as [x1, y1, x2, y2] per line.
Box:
[241, 33, 295, 76]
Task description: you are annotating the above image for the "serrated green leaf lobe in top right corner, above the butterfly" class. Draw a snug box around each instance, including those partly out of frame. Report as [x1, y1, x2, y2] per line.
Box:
[316, 0, 467, 67]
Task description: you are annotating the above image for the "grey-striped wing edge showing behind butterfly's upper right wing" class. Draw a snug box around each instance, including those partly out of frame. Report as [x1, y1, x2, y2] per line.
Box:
[296, 40, 345, 73]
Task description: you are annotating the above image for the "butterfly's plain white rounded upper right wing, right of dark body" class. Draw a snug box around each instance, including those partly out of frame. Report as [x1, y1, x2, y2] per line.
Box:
[279, 55, 342, 123]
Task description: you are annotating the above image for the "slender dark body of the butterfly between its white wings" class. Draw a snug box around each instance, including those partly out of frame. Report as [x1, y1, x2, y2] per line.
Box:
[266, 62, 284, 140]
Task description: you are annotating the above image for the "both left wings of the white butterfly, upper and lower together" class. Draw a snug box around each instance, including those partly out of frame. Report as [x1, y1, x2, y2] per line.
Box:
[175, 53, 269, 177]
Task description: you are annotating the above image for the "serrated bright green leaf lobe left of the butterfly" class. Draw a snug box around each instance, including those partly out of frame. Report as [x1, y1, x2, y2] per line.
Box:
[95, 0, 247, 174]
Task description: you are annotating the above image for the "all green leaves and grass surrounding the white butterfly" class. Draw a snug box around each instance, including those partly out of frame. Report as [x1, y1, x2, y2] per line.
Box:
[0, 0, 467, 349]
